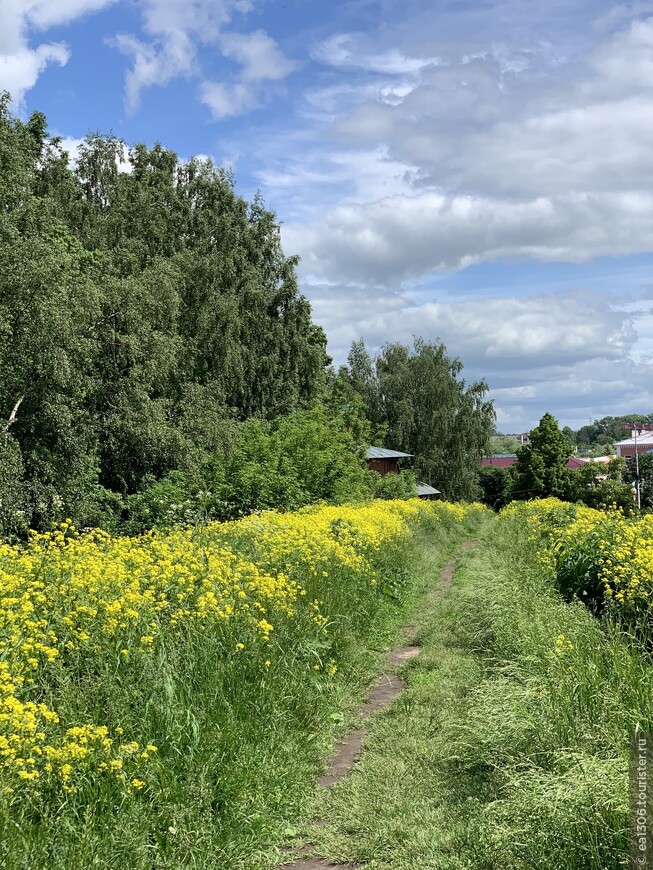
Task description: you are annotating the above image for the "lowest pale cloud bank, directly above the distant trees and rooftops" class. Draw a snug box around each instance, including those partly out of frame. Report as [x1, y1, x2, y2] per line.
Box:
[305, 284, 653, 430]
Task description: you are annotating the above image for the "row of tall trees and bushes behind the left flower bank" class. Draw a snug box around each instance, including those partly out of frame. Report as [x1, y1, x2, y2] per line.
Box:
[0, 95, 493, 536]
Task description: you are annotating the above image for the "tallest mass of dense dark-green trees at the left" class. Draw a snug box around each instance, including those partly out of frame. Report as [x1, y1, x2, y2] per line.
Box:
[0, 95, 328, 532]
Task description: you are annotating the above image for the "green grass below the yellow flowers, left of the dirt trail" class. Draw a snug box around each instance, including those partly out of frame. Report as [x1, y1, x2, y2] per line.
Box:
[0, 506, 478, 870]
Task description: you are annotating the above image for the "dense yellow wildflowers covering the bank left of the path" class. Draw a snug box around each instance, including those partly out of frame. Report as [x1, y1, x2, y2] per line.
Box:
[0, 500, 483, 802]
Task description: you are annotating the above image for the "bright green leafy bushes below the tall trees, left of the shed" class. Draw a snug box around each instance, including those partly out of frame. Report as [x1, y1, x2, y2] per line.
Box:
[124, 404, 374, 533]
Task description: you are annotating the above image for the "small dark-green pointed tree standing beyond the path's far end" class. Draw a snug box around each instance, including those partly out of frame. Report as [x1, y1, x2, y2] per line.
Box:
[512, 412, 570, 500]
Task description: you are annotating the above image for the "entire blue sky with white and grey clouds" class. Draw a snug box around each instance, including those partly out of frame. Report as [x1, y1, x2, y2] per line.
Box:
[0, 0, 653, 432]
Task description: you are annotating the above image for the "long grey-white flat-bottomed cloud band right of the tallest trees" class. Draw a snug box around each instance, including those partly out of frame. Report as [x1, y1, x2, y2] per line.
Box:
[283, 191, 653, 285]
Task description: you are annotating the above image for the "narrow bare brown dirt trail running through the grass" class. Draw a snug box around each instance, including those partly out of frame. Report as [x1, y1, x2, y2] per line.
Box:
[281, 540, 476, 870]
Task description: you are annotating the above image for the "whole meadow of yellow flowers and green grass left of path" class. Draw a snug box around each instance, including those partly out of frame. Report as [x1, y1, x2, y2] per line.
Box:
[0, 500, 486, 870]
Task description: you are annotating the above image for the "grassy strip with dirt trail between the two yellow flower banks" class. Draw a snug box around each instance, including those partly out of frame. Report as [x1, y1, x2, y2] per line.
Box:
[307, 508, 653, 870]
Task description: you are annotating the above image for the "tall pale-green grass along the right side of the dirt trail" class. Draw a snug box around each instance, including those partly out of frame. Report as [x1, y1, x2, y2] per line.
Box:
[438, 516, 653, 870]
